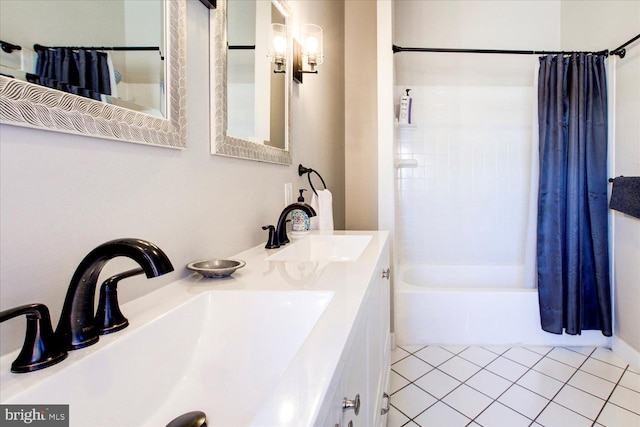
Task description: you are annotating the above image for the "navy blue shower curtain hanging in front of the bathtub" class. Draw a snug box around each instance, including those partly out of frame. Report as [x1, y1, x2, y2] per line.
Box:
[537, 54, 612, 336]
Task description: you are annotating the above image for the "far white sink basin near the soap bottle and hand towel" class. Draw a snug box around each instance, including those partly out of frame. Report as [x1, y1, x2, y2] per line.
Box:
[266, 235, 371, 262]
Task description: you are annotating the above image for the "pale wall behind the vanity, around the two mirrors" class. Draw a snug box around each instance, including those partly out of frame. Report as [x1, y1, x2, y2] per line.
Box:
[0, 0, 344, 354]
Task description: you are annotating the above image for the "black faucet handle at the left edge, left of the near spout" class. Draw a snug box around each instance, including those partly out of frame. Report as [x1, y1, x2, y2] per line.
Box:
[0, 303, 67, 374]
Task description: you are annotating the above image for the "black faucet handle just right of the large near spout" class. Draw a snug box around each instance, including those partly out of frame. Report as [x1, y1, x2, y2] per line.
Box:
[95, 268, 144, 335]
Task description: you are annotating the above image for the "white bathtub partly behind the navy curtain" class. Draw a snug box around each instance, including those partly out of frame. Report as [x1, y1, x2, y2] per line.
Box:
[394, 264, 610, 347]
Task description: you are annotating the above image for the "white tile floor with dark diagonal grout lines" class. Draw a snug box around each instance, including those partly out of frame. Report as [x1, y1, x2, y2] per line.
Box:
[387, 346, 640, 427]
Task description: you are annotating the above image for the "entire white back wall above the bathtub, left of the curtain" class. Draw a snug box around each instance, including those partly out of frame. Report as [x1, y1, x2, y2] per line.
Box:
[394, 1, 560, 265]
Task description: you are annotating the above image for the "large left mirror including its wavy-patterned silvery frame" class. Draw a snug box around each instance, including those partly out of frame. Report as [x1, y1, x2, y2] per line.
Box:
[0, 0, 186, 148]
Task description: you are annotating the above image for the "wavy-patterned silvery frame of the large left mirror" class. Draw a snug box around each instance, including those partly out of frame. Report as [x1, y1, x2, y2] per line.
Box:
[0, 0, 187, 149]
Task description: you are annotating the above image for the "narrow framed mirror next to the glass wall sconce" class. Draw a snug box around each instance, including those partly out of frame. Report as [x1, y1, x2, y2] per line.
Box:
[212, 0, 291, 164]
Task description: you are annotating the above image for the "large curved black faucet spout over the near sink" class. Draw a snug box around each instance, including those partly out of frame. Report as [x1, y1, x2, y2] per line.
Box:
[56, 239, 173, 350]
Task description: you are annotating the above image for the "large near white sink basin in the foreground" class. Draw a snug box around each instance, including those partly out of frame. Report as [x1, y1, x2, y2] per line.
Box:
[2, 291, 333, 426]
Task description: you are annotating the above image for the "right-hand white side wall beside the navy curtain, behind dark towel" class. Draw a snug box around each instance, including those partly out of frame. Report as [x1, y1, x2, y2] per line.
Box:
[562, 0, 640, 369]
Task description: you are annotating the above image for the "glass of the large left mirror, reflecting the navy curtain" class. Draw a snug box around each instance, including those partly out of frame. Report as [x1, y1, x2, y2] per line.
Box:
[0, 0, 165, 117]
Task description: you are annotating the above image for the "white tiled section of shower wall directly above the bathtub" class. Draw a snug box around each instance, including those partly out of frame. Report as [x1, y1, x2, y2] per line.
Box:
[395, 86, 533, 265]
